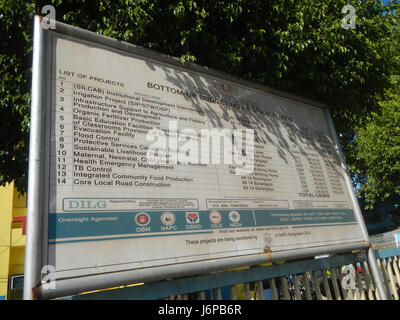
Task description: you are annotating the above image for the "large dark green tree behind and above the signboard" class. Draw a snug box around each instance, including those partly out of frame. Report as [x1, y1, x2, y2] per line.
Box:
[0, 0, 399, 209]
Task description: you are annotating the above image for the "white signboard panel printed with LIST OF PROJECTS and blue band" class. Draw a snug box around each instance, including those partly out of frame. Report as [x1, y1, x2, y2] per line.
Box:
[47, 33, 364, 277]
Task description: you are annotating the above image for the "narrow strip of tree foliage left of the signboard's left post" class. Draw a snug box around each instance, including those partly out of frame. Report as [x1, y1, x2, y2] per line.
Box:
[0, 1, 34, 190]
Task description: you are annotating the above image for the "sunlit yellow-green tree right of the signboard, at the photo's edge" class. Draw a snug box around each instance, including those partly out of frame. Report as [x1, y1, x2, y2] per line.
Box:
[346, 23, 400, 209]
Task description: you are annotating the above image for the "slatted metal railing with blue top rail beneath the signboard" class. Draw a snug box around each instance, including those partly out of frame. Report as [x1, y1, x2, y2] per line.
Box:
[65, 248, 400, 300]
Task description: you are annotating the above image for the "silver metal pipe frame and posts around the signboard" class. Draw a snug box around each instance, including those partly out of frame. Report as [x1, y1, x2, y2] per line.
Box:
[24, 16, 385, 299]
